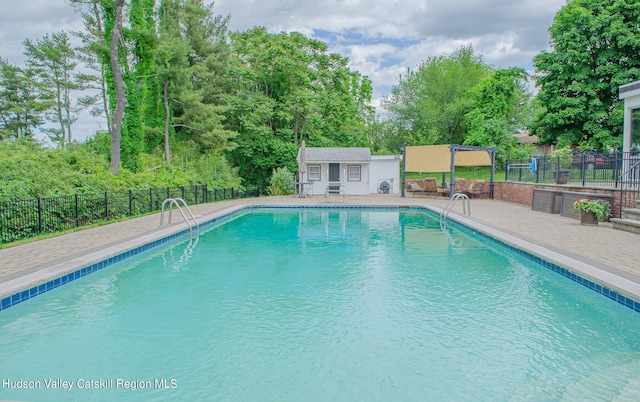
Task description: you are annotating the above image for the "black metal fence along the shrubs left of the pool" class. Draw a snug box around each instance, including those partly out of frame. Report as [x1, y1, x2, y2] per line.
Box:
[0, 185, 260, 244]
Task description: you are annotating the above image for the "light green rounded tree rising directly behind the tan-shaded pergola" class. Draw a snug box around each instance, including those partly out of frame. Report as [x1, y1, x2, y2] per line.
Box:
[383, 46, 491, 145]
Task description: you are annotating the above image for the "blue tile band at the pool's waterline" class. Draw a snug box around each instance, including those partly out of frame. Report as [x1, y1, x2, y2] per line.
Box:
[0, 205, 640, 312]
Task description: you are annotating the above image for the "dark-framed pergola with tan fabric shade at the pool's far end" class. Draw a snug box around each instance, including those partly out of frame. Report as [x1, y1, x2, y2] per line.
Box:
[402, 145, 497, 198]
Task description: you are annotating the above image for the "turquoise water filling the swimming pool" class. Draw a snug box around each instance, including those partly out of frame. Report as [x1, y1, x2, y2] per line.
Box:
[0, 209, 640, 401]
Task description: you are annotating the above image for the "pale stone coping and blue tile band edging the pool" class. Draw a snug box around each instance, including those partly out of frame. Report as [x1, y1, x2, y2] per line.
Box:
[0, 204, 640, 312]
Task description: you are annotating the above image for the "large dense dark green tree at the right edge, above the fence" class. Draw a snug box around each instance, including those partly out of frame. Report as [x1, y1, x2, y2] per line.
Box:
[532, 0, 640, 149]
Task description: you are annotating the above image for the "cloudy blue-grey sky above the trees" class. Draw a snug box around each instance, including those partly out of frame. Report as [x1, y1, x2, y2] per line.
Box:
[0, 0, 565, 140]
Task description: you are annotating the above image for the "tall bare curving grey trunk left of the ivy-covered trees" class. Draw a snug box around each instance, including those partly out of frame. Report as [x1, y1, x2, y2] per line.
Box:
[109, 0, 127, 175]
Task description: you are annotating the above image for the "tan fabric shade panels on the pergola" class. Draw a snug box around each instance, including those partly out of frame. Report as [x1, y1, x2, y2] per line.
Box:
[404, 145, 491, 173]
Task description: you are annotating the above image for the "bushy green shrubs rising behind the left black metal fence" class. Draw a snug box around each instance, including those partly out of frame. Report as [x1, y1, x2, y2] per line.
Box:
[0, 139, 243, 200]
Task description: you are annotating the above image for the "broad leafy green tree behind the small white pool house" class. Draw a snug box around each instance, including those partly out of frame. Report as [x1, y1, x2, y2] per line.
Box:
[226, 28, 373, 187]
